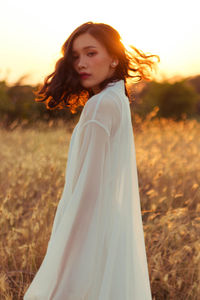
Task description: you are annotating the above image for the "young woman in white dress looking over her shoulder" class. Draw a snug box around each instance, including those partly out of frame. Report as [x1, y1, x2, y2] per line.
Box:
[24, 22, 159, 300]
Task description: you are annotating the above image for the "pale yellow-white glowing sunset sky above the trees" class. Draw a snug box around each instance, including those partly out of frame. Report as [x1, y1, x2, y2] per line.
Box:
[0, 0, 200, 84]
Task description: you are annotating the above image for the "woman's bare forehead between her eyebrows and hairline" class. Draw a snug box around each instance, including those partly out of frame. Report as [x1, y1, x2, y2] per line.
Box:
[72, 33, 104, 52]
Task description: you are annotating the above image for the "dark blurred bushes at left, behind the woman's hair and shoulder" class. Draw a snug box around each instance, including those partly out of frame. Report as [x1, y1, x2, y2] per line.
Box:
[0, 81, 80, 126]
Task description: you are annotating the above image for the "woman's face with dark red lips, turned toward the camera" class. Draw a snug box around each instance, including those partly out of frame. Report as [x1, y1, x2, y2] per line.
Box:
[72, 33, 118, 94]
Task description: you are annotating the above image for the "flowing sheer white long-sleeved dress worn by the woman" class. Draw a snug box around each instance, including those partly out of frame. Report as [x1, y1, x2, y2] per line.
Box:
[24, 80, 152, 300]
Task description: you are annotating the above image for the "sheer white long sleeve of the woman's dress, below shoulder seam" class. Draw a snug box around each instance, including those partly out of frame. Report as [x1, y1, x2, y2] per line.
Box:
[47, 120, 109, 299]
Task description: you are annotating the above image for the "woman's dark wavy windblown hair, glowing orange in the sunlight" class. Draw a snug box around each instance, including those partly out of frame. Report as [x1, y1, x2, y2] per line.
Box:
[34, 22, 160, 114]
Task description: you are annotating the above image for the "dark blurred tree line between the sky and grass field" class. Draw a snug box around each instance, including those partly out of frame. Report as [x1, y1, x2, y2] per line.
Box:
[0, 75, 200, 126]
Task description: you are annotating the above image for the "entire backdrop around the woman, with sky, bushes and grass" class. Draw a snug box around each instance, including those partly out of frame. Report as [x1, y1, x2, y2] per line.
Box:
[0, 0, 200, 300]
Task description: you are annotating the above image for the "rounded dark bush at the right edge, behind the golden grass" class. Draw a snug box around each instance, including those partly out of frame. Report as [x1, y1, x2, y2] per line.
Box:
[133, 80, 200, 120]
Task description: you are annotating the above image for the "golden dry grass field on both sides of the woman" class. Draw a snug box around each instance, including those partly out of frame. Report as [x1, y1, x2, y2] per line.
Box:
[0, 116, 200, 300]
